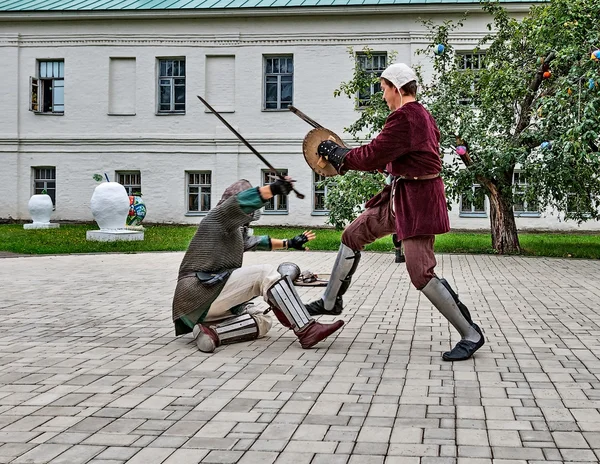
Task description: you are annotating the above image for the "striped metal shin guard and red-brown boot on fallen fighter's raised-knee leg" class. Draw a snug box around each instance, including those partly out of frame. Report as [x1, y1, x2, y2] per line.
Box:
[267, 277, 344, 348]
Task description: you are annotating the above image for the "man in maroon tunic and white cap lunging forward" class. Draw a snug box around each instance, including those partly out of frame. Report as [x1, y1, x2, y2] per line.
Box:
[307, 63, 484, 361]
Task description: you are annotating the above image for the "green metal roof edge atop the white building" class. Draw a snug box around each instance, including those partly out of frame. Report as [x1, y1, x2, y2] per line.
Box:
[0, 0, 535, 12]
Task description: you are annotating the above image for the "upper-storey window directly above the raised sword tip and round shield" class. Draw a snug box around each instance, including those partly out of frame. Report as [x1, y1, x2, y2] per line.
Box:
[264, 56, 294, 110]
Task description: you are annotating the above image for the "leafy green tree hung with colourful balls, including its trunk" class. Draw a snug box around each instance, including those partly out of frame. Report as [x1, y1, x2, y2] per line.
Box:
[328, 0, 600, 253]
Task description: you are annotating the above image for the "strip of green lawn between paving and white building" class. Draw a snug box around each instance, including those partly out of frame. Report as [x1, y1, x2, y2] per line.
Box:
[0, 224, 600, 259]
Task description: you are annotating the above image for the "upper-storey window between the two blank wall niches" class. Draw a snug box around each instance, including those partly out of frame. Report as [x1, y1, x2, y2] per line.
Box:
[158, 58, 185, 113]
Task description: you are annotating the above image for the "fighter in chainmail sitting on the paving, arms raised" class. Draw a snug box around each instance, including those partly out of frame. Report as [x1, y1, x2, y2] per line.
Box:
[173, 178, 344, 353]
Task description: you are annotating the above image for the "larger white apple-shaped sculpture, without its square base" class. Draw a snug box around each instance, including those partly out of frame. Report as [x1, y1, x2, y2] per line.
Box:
[90, 182, 129, 230]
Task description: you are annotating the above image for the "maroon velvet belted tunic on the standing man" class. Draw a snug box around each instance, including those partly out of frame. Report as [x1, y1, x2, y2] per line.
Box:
[344, 102, 450, 240]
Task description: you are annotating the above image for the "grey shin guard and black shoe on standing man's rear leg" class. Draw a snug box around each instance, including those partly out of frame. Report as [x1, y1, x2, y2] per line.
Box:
[421, 277, 485, 361]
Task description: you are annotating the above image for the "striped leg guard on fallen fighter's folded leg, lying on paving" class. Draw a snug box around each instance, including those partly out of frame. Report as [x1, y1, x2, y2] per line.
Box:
[194, 314, 258, 353]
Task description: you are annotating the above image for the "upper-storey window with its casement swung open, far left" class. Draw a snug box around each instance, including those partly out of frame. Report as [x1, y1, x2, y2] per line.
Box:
[29, 58, 65, 116]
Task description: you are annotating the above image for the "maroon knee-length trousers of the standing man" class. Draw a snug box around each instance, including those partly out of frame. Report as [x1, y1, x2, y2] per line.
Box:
[342, 202, 437, 290]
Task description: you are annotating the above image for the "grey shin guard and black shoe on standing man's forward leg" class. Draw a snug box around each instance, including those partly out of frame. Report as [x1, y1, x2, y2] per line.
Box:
[306, 243, 360, 316]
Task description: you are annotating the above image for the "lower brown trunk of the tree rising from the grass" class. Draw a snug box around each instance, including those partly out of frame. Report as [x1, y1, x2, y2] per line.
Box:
[489, 189, 521, 255]
